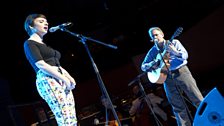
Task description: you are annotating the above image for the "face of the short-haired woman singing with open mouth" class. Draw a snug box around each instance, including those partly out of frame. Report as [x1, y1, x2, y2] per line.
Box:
[33, 17, 48, 36]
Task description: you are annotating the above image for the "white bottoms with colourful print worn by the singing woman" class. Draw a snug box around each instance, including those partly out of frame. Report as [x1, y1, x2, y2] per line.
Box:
[36, 71, 77, 126]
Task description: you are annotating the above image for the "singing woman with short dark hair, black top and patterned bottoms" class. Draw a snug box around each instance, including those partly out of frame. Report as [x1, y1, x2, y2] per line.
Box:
[24, 14, 77, 126]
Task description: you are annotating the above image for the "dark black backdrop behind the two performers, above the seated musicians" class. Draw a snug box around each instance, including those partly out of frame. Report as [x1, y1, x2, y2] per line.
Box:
[0, 0, 224, 125]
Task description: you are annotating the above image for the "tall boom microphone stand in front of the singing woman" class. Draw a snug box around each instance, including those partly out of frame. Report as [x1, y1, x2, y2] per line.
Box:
[60, 27, 121, 126]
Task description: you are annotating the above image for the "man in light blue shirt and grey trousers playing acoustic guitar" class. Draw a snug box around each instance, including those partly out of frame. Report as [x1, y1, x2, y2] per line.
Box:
[141, 27, 203, 126]
